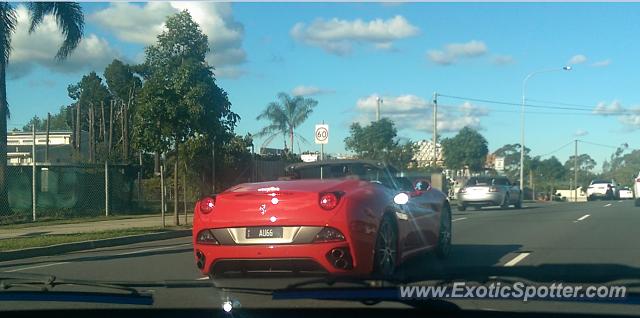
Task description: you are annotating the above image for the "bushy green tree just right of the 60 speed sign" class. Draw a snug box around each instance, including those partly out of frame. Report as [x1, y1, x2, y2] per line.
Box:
[344, 118, 416, 168]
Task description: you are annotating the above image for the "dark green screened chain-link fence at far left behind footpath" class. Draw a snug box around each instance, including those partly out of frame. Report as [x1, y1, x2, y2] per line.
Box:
[0, 164, 138, 224]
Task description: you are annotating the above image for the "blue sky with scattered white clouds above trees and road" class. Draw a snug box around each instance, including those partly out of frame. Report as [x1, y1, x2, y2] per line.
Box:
[7, 2, 640, 171]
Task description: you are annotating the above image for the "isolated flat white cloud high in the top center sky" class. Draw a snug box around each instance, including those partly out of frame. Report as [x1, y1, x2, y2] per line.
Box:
[290, 15, 420, 55]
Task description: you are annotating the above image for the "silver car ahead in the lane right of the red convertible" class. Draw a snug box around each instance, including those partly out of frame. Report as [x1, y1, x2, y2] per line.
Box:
[457, 176, 522, 211]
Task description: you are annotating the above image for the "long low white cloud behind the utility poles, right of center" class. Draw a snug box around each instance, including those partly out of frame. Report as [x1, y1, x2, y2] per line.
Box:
[355, 94, 489, 133]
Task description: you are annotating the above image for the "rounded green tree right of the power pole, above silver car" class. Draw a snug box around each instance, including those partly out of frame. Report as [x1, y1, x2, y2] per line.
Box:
[442, 127, 489, 172]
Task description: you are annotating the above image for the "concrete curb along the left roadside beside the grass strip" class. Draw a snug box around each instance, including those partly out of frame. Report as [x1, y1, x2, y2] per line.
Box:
[0, 229, 191, 262]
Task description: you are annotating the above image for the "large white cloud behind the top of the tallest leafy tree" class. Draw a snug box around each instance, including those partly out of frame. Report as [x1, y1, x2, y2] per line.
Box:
[89, 1, 247, 78]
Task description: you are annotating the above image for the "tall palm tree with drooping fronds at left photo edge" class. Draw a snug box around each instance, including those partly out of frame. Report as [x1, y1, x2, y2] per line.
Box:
[0, 2, 84, 210]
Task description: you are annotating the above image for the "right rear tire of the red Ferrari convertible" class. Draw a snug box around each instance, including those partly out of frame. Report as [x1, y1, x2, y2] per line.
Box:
[373, 214, 398, 279]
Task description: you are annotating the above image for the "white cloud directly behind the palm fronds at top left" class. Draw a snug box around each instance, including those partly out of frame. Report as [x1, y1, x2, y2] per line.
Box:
[8, 5, 120, 78]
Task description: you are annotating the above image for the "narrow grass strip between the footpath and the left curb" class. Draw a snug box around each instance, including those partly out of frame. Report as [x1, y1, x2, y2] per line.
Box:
[0, 227, 182, 251]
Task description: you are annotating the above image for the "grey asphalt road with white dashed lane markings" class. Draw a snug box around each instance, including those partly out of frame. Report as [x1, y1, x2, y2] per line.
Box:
[0, 201, 640, 310]
